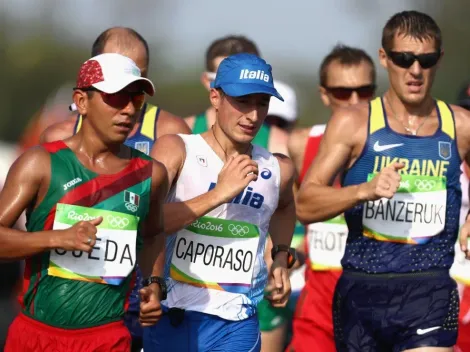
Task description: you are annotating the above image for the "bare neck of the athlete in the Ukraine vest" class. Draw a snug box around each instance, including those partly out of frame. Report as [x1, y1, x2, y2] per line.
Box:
[384, 89, 434, 121]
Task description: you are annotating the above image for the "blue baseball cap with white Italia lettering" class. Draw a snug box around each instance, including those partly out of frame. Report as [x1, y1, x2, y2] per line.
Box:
[211, 53, 284, 101]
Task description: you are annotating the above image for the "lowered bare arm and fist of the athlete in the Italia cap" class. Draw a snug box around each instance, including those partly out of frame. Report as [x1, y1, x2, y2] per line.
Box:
[266, 155, 296, 307]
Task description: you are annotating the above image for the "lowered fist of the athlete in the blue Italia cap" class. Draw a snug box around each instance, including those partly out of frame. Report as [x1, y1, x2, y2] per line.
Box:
[265, 254, 291, 308]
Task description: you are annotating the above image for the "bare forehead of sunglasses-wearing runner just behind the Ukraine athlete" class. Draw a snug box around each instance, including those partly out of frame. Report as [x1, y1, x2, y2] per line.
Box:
[326, 60, 374, 88]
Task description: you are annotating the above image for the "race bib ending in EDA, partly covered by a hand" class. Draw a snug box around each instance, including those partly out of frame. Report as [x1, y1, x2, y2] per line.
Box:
[48, 204, 139, 285]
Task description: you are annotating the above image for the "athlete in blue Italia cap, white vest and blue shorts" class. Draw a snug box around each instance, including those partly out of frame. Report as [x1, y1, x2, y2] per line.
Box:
[144, 53, 295, 352]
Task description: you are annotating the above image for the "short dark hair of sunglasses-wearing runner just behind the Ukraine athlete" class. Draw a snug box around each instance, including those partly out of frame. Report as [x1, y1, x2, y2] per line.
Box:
[320, 44, 376, 87]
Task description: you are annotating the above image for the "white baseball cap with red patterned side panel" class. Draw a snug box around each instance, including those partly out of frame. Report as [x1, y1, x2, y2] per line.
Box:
[75, 53, 155, 95]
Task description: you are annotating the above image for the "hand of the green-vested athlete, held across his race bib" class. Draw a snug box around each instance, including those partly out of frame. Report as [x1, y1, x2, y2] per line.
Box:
[52, 216, 103, 253]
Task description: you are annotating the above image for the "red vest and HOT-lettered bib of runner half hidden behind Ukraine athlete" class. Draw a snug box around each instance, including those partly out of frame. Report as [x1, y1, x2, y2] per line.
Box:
[299, 125, 348, 275]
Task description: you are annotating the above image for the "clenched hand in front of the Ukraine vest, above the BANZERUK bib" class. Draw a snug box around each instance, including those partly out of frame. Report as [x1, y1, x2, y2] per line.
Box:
[359, 163, 405, 201]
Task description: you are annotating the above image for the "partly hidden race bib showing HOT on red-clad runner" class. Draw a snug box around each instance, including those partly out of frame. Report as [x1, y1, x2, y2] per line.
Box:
[307, 215, 348, 271]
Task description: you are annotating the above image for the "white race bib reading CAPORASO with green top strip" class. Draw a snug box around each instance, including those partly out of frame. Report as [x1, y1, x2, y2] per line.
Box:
[170, 216, 259, 293]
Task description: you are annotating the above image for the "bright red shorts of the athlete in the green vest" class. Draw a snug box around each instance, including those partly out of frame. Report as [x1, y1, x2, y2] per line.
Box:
[4, 314, 131, 352]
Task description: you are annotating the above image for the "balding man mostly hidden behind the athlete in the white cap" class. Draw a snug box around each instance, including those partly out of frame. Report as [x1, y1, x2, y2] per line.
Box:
[42, 27, 191, 352]
